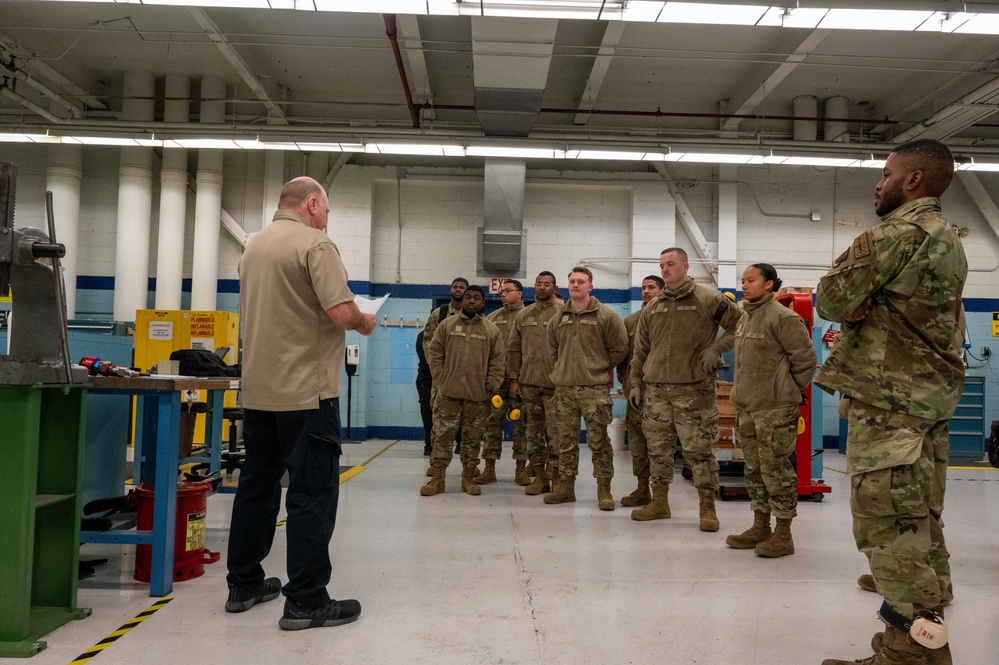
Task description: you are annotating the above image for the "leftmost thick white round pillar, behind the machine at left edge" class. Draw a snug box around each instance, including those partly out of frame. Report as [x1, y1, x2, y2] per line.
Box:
[45, 145, 83, 319]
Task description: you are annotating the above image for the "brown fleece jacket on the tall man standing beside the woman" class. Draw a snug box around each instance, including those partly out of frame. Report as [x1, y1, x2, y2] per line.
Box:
[629, 277, 742, 385]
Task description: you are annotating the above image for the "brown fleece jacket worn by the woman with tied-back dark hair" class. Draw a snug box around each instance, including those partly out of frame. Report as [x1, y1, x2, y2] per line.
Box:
[732, 294, 816, 411]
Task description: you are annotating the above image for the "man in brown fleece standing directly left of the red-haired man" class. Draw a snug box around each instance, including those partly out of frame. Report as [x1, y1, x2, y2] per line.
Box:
[507, 271, 562, 496]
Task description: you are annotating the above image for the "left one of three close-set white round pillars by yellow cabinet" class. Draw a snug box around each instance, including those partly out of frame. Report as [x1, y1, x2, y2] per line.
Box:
[114, 72, 155, 321]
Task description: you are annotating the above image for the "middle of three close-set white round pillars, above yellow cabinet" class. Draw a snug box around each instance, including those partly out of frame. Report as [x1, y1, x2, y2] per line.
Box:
[155, 74, 191, 309]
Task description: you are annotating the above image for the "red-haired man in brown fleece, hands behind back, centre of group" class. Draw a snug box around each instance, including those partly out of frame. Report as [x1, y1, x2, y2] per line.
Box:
[545, 267, 628, 510]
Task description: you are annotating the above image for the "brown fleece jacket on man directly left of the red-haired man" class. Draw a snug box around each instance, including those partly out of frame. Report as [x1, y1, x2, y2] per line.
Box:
[506, 298, 562, 388]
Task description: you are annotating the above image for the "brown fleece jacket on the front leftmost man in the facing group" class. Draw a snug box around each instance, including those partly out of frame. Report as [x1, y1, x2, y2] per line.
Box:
[427, 313, 506, 402]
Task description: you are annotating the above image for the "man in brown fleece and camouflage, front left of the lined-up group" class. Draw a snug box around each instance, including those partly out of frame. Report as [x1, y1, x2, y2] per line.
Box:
[420, 285, 506, 496]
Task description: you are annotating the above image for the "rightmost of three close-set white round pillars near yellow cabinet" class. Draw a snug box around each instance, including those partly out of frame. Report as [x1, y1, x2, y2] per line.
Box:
[191, 76, 225, 311]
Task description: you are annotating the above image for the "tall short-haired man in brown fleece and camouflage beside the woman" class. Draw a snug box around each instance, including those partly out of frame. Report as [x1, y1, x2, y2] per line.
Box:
[628, 247, 742, 531]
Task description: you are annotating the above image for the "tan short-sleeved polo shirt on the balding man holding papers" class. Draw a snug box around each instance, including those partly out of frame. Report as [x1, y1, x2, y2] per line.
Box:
[239, 210, 354, 411]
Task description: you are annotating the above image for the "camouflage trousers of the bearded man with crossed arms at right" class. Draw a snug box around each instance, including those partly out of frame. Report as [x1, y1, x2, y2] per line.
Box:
[846, 400, 954, 617]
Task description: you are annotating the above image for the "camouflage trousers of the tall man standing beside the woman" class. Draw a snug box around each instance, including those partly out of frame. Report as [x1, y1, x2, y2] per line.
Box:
[642, 379, 718, 489]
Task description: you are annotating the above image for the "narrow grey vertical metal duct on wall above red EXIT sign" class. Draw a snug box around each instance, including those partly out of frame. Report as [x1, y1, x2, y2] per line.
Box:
[478, 159, 527, 277]
